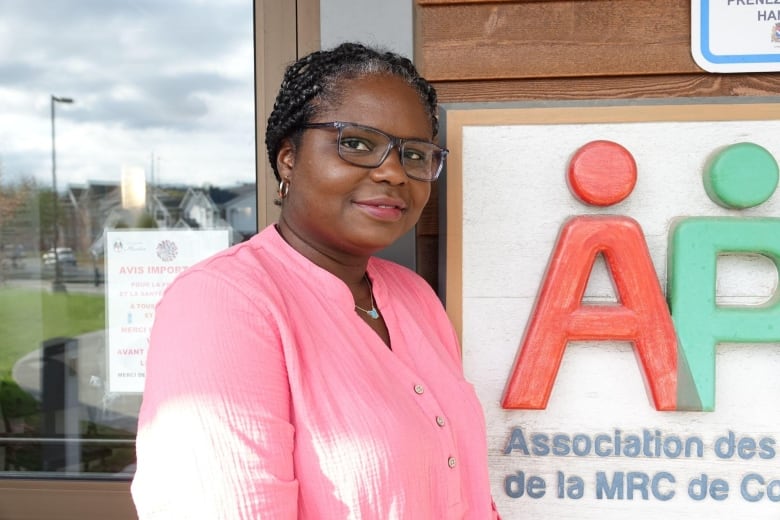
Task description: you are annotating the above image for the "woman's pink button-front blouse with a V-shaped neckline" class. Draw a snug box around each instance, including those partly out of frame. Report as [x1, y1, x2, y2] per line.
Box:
[132, 226, 497, 520]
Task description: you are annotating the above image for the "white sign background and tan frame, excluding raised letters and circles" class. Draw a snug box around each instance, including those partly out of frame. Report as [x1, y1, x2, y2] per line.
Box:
[443, 104, 780, 520]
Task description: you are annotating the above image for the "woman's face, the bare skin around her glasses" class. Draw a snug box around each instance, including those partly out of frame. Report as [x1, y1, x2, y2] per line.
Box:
[278, 75, 432, 259]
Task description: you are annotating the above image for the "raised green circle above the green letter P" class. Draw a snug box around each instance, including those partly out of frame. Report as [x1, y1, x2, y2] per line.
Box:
[704, 143, 778, 209]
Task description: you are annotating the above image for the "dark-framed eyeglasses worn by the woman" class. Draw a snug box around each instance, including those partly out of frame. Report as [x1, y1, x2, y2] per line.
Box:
[302, 121, 449, 182]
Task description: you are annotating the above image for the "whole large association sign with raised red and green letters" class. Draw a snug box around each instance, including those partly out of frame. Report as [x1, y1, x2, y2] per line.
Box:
[442, 100, 780, 520]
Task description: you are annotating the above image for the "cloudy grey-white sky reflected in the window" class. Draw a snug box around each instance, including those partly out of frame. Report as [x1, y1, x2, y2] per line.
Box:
[0, 0, 255, 189]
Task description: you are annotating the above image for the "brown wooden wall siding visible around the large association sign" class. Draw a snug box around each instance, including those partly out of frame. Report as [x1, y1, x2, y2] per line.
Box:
[414, 0, 780, 287]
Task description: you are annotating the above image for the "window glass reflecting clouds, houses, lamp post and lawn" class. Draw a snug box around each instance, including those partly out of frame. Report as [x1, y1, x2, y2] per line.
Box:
[0, 0, 257, 478]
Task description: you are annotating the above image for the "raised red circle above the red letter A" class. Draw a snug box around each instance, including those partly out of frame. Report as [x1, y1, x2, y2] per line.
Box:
[567, 141, 636, 206]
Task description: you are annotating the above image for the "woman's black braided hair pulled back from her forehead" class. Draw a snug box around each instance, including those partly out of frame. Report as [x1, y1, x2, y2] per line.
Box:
[265, 43, 439, 180]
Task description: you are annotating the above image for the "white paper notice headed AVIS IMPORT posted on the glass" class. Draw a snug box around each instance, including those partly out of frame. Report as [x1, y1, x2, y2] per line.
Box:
[105, 229, 229, 393]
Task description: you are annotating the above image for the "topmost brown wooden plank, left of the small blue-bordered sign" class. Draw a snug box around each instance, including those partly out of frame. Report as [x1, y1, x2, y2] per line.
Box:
[415, 0, 701, 81]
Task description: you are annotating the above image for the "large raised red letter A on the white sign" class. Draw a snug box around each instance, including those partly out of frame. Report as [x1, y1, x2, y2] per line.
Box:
[502, 216, 677, 410]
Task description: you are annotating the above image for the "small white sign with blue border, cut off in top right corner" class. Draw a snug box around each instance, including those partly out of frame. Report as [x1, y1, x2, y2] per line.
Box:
[691, 0, 780, 72]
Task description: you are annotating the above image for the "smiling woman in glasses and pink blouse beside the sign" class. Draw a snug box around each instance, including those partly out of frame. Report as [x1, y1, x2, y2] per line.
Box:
[133, 44, 497, 520]
